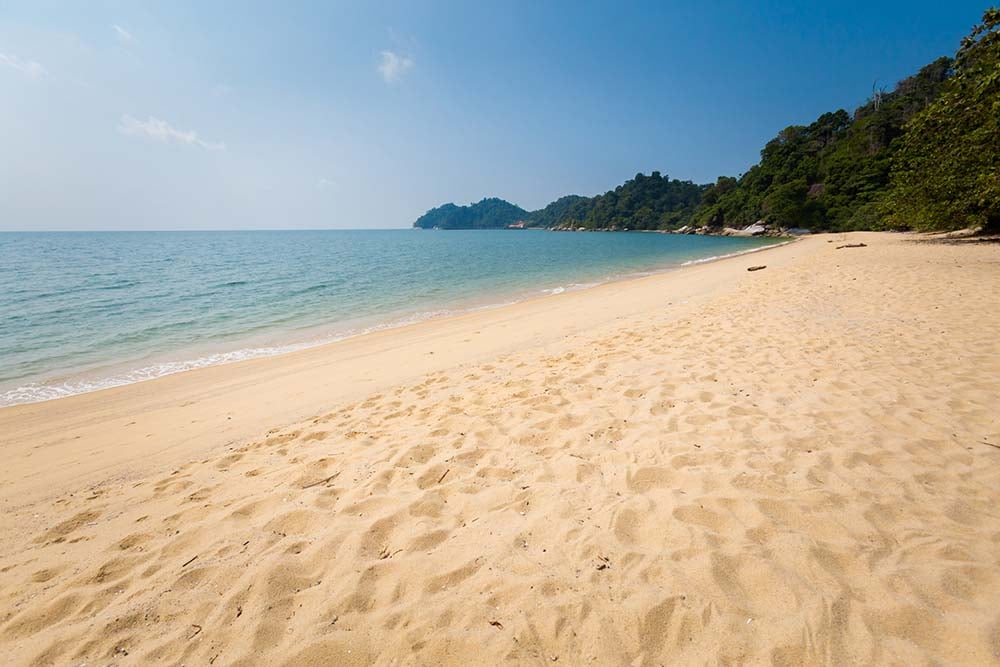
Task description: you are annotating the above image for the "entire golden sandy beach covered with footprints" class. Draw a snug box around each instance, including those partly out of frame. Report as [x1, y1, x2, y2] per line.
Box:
[0, 234, 1000, 665]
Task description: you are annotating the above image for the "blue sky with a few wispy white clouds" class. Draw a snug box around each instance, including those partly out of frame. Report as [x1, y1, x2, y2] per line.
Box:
[0, 0, 987, 230]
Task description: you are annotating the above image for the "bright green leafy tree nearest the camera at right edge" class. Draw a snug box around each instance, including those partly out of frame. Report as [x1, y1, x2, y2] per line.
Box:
[882, 9, 1000, 231]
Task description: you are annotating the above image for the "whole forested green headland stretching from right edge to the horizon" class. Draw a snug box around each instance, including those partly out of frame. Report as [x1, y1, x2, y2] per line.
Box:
[413, 9, 1000, 233]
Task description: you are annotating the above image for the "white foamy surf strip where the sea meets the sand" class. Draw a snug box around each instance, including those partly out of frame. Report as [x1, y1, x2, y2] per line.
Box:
[0, 237, 797, 410]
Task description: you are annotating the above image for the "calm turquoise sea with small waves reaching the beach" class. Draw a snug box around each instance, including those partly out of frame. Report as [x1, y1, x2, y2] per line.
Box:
[0, 230, 773, 405]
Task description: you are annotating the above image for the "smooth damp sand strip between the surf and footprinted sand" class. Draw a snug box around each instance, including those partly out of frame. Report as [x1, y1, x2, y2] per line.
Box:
[0, 236, 796, 508]
